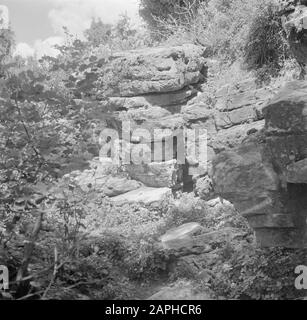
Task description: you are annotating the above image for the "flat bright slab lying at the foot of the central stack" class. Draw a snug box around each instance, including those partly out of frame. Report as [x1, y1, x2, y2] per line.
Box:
[112, 187, 172, 207]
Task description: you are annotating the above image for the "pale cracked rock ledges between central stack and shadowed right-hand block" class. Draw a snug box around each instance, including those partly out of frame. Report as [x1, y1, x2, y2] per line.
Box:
[190, 78, 275, 200]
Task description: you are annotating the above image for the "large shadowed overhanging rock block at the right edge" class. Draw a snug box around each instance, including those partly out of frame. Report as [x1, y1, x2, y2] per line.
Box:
[213, 81, 307, 248]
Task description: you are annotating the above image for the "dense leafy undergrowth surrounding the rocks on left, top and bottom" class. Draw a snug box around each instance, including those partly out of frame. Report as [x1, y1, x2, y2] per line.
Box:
[0, 0, 305, 299]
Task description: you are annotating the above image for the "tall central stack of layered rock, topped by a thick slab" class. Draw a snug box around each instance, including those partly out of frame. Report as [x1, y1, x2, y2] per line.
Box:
[101, 45, 207, 189]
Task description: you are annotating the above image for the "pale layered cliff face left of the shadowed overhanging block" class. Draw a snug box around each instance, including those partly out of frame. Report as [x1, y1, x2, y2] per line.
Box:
[103, 45, 273, 192]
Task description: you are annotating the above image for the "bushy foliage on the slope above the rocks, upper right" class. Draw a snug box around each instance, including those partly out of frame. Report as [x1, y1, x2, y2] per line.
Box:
[147, 0, 289, 78]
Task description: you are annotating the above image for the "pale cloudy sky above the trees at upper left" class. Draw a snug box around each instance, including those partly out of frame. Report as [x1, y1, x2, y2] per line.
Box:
[0, 0, 139, 56]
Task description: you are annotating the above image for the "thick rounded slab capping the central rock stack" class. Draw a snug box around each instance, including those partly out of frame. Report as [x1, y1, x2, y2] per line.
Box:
[102, 44, 205, 97]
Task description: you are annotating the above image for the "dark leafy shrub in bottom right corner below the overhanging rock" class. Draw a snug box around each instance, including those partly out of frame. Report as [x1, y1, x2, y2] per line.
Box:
[211, 246, 306, 300]
